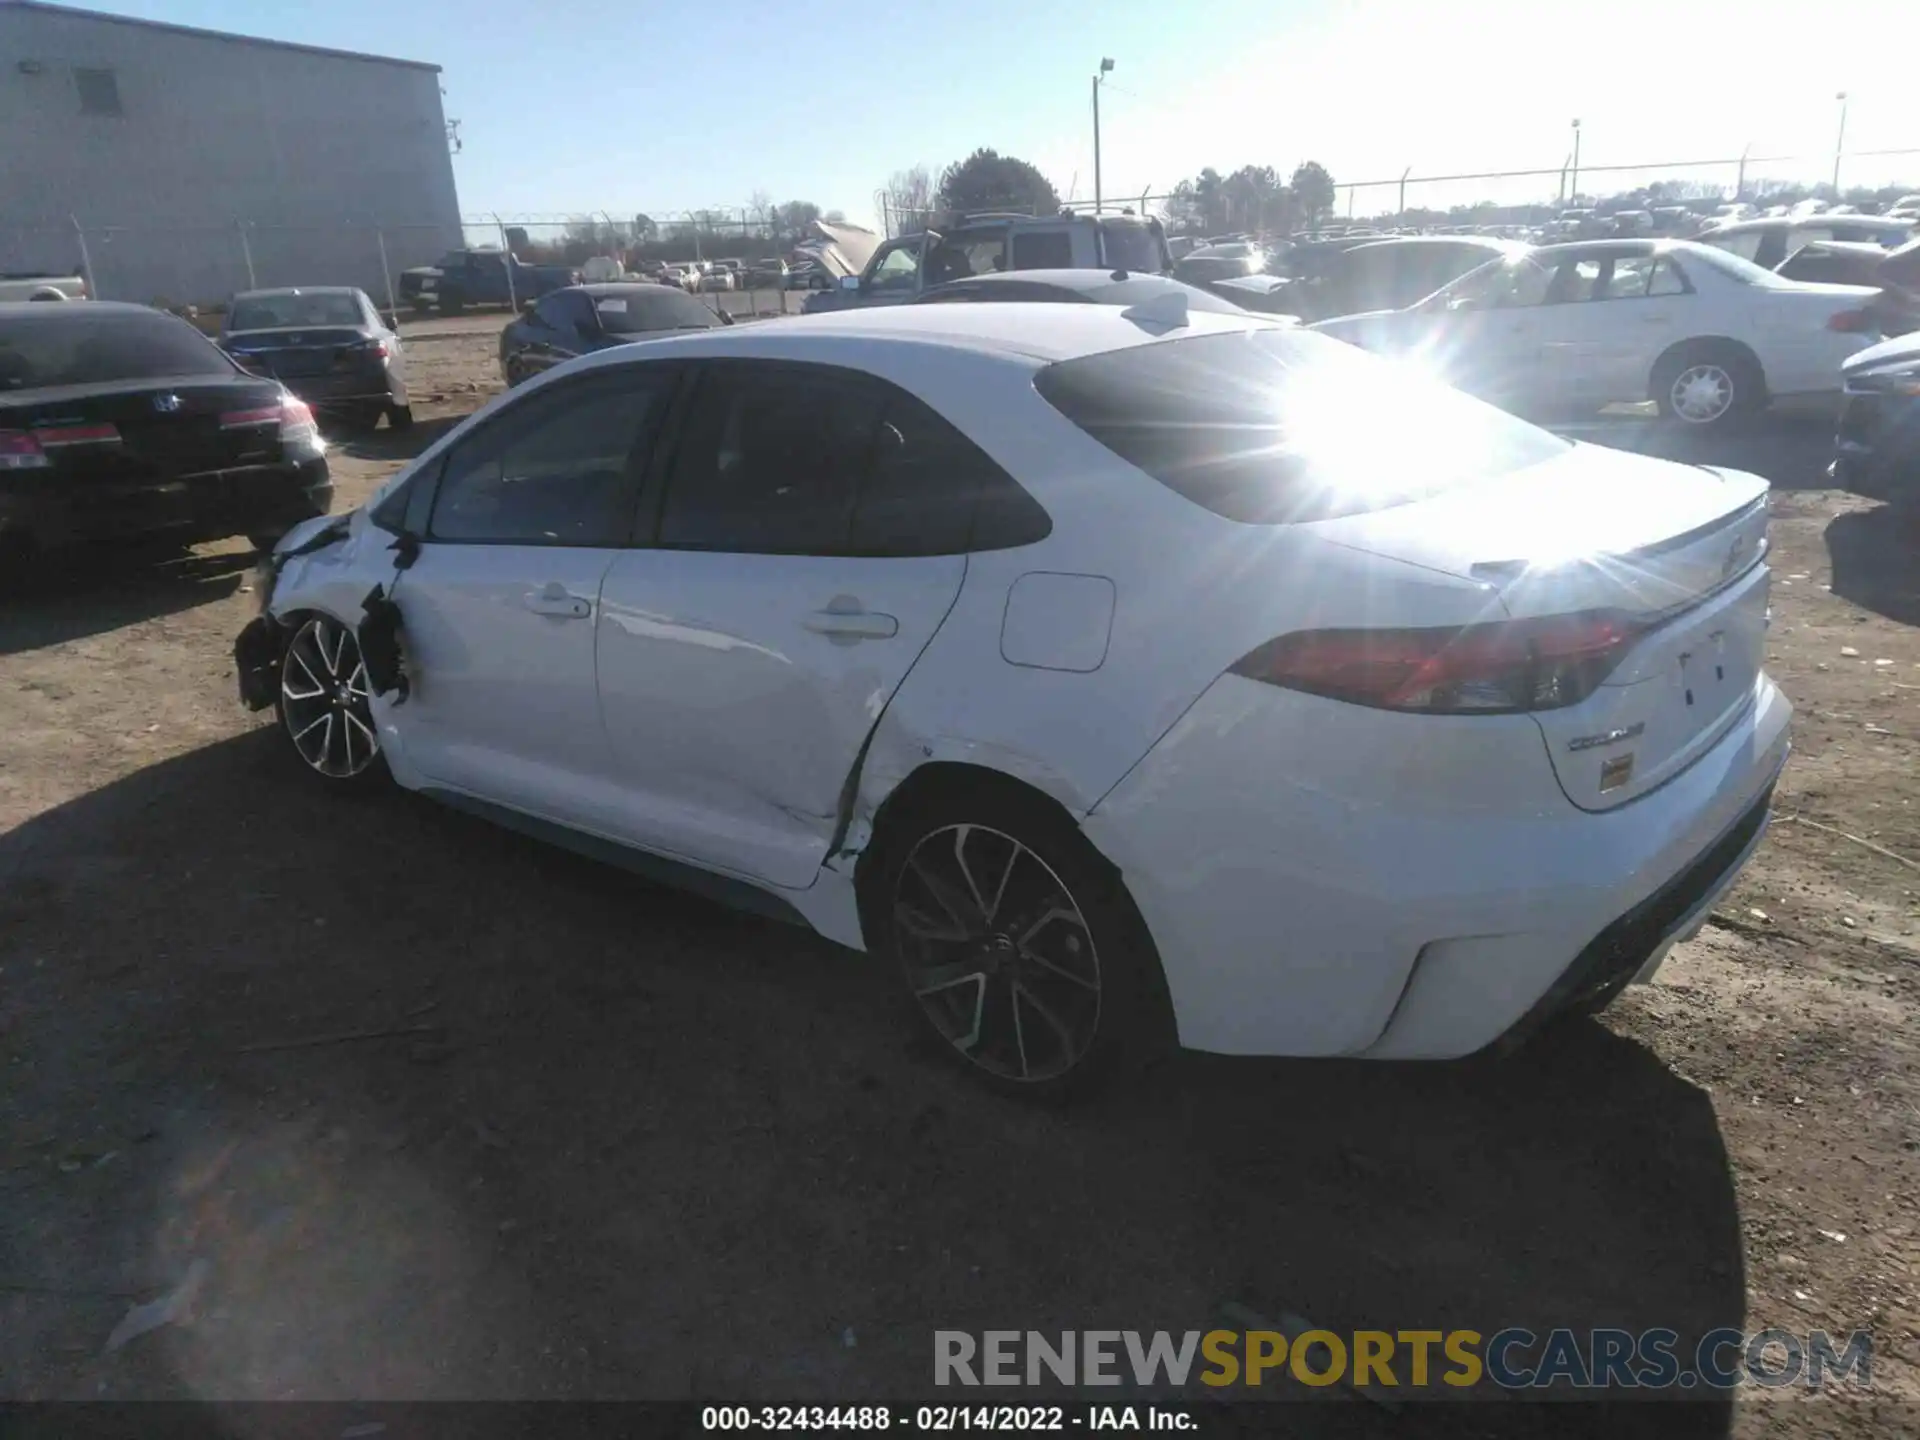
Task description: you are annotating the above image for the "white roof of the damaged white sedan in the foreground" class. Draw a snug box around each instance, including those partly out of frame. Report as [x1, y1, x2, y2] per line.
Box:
[568, 301, 1288, 365]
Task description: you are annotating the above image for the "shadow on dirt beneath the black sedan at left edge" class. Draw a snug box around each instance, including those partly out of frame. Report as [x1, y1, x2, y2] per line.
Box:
[0, 541, 259, 655]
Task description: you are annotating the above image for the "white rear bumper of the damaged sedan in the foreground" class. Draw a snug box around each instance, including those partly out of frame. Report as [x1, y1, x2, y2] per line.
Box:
[1085, 676, 1791, 1060]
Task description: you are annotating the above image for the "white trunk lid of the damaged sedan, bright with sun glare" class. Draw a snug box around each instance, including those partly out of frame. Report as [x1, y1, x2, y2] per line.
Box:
[1311, 445, 1768, 810]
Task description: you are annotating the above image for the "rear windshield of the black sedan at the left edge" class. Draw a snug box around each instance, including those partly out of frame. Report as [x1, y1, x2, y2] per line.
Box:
[0, 303, 234, 392]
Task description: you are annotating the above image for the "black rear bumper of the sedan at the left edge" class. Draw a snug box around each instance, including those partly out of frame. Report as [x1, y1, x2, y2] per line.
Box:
[0, 455, 334, 549]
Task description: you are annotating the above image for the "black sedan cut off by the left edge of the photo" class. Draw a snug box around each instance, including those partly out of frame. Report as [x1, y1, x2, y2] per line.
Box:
[0, 301, 334, 574]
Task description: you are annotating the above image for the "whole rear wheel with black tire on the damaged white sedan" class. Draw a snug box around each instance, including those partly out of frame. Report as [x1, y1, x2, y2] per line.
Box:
[860, 778, 1173, 1098]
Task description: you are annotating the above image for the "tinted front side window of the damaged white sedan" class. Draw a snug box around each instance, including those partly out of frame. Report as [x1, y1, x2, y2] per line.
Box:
[428, 365, 674, 549]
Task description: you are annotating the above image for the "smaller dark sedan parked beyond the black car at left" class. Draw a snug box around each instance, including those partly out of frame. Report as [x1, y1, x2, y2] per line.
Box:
[221, 286, 413, 430]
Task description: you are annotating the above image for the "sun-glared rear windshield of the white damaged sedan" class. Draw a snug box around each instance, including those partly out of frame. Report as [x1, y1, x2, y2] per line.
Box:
[1035, 328, 1569, 524]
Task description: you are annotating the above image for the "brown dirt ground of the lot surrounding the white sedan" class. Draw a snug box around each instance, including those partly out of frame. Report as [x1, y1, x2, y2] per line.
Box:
[0, 336, 1920, 1436]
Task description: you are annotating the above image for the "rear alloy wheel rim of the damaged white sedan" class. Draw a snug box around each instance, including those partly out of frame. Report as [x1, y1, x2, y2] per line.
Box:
[893, 824, 1100, 1085]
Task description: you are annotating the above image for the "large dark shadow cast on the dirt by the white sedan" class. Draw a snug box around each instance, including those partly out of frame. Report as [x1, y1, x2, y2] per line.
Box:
[0, 744, 1743, 1434]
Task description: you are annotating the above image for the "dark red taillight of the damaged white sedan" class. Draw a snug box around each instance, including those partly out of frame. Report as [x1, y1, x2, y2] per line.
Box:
[1233, 611, 1640, 714]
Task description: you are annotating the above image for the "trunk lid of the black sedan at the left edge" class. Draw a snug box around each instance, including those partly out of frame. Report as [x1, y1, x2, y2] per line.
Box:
[0, 374, 280, 484]
